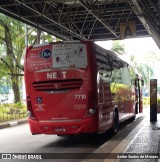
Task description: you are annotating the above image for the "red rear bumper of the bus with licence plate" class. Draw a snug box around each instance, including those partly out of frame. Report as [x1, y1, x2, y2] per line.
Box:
[28, 116, 98, 135]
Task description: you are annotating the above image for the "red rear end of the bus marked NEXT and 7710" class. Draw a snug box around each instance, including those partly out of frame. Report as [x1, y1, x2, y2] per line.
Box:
[25, 42, 98, 135]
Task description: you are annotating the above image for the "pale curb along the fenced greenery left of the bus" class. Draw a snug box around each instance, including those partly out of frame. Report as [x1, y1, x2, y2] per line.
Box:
[0, 118, 28, 129]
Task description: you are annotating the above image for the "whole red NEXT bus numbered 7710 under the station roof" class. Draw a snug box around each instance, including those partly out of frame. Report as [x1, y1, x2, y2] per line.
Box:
[25, 41, 142, 135]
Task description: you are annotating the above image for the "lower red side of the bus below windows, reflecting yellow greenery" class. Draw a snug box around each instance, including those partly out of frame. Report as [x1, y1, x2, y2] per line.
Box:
[98, 82, 135, 132]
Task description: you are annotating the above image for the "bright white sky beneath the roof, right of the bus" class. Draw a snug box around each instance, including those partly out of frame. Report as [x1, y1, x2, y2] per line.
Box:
[96, 37, 160, 85]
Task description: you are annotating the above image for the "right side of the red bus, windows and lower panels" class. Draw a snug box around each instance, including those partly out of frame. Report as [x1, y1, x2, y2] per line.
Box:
[95, 45, 138, 132]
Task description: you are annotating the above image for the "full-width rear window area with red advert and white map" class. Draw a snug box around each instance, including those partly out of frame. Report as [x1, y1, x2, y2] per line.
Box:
[27, 43, 87, 72]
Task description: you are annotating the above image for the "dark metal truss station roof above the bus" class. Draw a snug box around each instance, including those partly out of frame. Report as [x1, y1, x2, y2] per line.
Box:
[0, 0, 160, 47]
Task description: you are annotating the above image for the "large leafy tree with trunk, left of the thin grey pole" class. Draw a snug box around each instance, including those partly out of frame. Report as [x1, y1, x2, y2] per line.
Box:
[0, 14, 24, 103]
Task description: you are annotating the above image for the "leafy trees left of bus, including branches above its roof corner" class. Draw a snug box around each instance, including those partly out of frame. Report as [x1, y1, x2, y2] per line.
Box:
[0, 14, 57, 103]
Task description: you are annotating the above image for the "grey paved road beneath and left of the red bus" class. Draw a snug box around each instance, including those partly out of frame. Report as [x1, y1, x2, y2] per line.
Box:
[0, 113, 146, 162]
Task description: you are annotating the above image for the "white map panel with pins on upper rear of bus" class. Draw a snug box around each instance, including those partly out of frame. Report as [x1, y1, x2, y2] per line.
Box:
[52, 43, 87, 68]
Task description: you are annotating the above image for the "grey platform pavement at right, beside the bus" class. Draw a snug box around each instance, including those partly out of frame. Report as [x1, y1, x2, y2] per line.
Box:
[85, 108, 160, 162]
